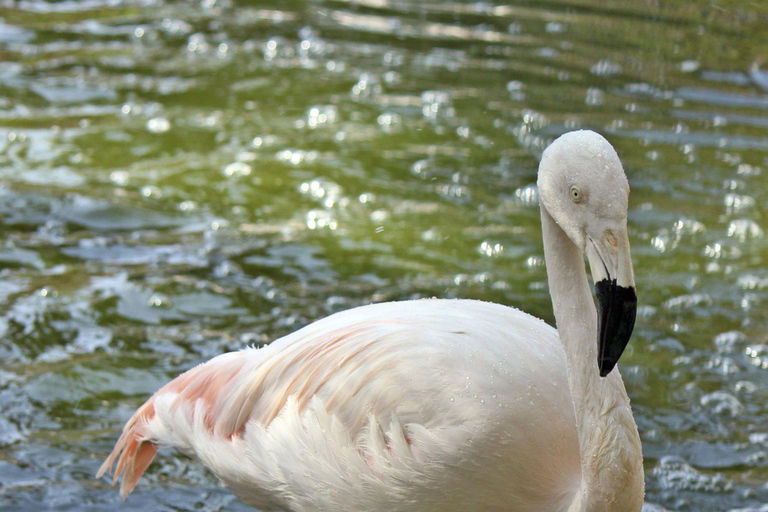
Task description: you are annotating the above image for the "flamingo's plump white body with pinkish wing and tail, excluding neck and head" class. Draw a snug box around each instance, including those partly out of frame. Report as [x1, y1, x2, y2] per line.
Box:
[102, 299, 581, 512]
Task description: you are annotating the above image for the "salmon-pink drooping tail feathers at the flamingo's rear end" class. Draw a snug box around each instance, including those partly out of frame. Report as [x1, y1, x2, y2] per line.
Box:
[96, 398, 157, 499]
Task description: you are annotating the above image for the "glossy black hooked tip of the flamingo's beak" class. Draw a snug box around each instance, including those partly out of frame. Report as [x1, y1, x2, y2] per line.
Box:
[595, 279, 637, 377]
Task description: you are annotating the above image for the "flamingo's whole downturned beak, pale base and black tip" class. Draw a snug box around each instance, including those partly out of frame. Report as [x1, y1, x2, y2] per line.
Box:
[586, 229, 637, 377]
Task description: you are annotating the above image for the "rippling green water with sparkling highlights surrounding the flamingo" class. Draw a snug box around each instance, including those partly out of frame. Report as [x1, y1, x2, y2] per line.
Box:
[0, 0, 768, 511]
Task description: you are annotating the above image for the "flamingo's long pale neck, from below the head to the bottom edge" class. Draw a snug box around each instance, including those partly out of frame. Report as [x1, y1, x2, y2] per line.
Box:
[541, 205, 644, 512]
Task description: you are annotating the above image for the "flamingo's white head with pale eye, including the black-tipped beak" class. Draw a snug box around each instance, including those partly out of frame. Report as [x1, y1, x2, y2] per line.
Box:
[538, 130, 637, 377]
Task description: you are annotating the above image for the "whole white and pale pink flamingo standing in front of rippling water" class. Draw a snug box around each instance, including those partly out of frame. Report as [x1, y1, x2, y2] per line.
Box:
[98, 130, 644, 512]
